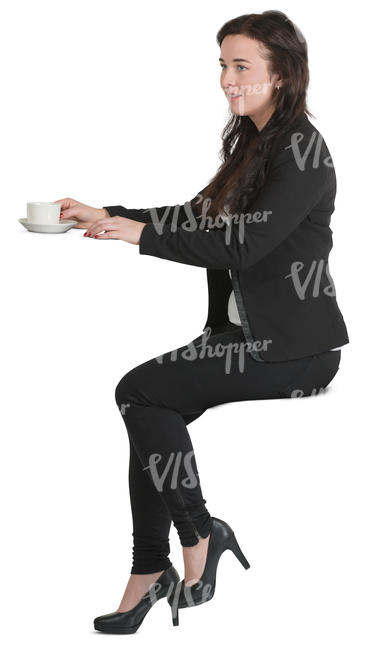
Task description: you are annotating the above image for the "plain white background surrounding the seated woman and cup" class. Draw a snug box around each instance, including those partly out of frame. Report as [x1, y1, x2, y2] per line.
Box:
[0, 0, 390, 650]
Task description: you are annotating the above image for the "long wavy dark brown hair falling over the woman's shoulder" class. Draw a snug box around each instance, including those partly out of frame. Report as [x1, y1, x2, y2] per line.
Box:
[191, 11, 314, 223]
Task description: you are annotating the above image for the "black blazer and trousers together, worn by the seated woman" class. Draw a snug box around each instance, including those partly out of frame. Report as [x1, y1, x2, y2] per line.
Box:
[105, 116, 349, 573]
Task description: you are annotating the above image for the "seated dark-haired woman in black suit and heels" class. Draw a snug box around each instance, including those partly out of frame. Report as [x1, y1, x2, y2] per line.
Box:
[56, 11, 349, 633]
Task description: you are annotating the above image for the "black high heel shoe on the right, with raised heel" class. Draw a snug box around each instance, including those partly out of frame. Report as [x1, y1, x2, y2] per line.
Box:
[168, 517, 250, 625]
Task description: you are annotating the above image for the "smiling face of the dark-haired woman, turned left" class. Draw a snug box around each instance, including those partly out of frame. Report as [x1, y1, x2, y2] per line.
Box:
[220, 34, 282, 131]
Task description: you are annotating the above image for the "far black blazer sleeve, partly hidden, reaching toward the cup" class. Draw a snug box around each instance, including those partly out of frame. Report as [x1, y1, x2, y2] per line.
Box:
[103, 190, 207, 232]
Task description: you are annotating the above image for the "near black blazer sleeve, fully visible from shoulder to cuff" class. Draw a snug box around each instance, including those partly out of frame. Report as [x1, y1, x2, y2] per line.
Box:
[139, 148, 330, 270]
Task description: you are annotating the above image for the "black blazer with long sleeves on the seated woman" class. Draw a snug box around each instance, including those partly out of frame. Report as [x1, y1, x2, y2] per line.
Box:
[105, 115, 349, 361]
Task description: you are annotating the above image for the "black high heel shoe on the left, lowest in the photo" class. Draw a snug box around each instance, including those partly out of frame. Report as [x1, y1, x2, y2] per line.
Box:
[93, 565, 180, 634]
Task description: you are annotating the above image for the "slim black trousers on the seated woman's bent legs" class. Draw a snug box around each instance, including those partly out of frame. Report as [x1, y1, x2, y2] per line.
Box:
[115, 325, 341, 573]
